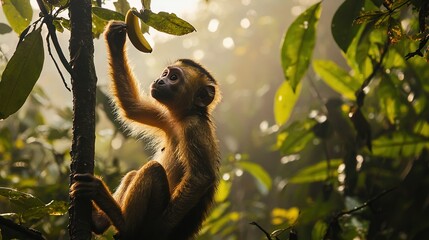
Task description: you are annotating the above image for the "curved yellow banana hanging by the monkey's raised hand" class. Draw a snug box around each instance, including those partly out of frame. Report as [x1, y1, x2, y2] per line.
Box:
[125, 9, 152, 53]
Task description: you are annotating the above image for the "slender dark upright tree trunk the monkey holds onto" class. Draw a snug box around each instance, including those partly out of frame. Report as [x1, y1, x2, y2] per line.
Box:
[69, 0, 97, 240]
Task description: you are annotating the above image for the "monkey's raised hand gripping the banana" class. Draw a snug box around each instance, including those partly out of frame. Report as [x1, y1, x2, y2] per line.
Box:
[104, 21, 127, 54]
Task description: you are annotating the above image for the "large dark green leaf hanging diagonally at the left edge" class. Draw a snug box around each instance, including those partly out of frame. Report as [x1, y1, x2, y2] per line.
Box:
[0, 29, 44, 119]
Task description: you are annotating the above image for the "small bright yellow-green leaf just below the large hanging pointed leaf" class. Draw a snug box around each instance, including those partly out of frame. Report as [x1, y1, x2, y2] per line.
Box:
[274, 82, 301, 125]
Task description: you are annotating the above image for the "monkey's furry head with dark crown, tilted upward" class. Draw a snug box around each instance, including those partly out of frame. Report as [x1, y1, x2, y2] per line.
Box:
[151, 59, 221, 115]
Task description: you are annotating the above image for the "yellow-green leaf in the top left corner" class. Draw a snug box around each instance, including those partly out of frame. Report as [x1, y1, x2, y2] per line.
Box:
[1, 0, 33, 34]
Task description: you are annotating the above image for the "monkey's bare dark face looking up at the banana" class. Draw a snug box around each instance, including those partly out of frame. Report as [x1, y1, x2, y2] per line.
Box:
[150, 66, 185, 105]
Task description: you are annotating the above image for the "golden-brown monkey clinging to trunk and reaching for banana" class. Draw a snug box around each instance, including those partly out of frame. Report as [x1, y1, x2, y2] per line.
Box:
[70, 21, 221, 240]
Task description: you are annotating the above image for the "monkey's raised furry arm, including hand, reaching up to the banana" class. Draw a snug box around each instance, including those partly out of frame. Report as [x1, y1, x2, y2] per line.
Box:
[105, 22, 169, 130]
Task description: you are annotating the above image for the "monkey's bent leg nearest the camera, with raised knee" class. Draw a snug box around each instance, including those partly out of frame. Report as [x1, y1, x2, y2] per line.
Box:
[121, 161, 170, 239]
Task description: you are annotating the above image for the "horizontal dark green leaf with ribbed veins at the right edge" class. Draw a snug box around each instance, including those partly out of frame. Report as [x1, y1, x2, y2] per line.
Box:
[372, 131, 429, 159]
